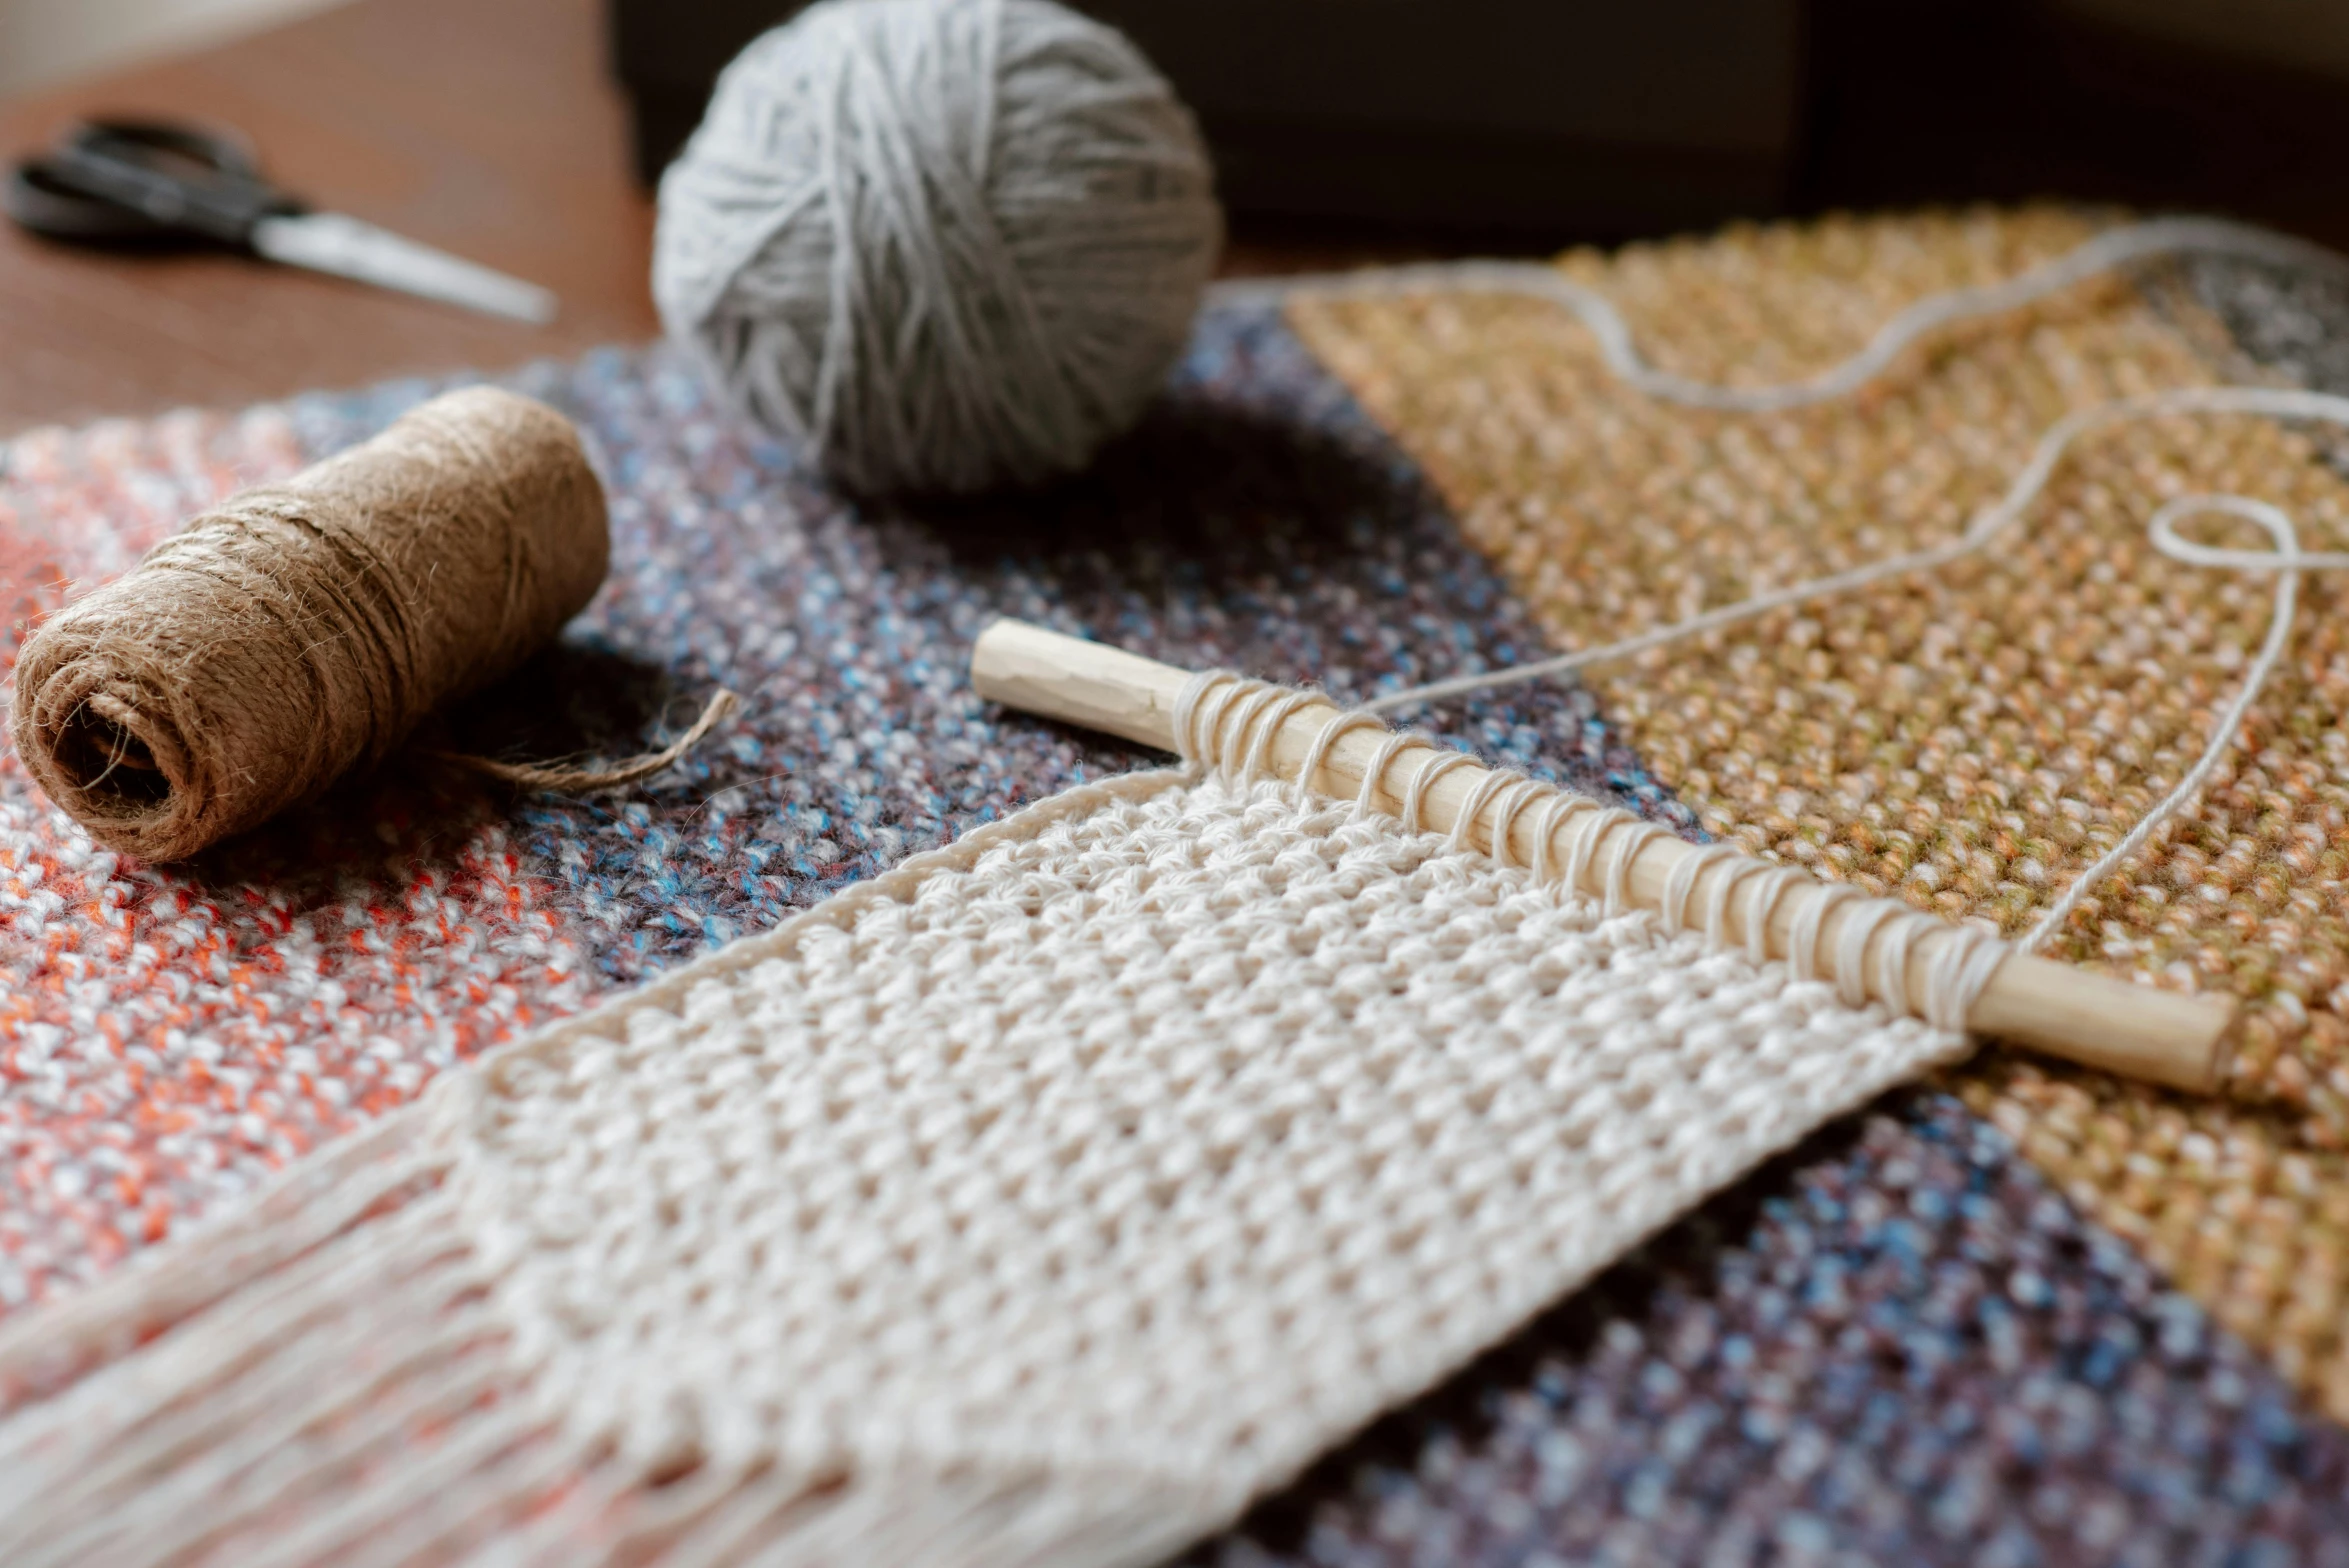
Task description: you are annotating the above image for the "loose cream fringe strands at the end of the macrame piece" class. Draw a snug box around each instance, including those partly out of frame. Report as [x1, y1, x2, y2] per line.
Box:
[0, 1101, 1229, 1568]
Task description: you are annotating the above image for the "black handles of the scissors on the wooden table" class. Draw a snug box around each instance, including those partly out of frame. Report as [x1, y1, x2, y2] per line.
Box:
[0, 120, 301, 246]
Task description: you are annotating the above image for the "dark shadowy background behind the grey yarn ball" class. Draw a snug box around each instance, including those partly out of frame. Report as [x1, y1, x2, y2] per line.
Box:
[608, 0, 2349, 255]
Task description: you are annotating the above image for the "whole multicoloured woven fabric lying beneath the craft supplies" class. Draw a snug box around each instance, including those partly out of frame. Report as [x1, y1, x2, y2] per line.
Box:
[0, 214, 2349, 1566]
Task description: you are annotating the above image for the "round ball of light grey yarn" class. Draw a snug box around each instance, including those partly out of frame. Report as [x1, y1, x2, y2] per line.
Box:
[653, 0, 1224, 493]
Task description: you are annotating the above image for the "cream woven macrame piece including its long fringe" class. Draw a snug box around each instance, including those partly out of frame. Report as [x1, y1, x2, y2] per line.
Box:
[0, 727, 1964, 1568]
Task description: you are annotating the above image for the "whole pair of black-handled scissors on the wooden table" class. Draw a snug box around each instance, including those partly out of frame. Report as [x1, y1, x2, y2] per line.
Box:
[0, 120, 554, 326]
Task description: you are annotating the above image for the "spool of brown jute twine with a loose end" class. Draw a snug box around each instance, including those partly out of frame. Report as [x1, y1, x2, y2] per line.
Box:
[14, 387, 733, 859]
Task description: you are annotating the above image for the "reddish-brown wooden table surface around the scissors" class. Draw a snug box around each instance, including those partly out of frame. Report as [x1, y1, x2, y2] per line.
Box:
[0, 0, 1426, 434]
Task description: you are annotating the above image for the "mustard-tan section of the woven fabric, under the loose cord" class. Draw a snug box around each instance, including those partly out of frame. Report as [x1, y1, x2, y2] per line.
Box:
[1290, 201, 2349, 1415]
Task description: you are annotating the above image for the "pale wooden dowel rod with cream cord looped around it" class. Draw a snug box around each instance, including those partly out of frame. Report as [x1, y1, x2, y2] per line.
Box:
[970, 620, 2236, 1091]
